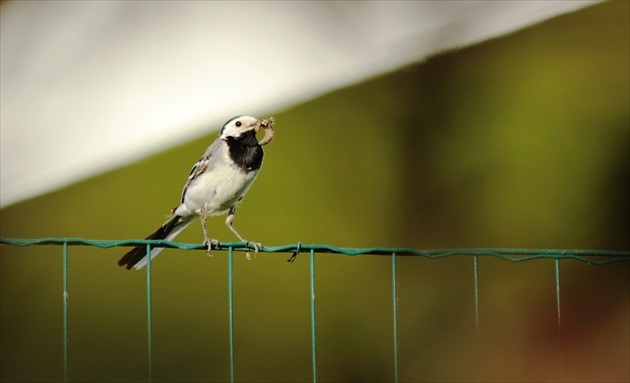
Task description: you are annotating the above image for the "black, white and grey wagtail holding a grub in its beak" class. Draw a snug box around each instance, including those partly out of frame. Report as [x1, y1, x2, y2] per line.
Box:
[118, 116, 274, 270]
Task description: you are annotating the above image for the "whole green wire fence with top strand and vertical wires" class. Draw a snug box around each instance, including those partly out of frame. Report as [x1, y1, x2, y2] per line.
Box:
[0, 238, 630, 382]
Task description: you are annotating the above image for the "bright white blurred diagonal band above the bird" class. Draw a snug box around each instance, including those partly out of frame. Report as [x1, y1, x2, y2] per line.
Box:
[0, 1, 596, 206]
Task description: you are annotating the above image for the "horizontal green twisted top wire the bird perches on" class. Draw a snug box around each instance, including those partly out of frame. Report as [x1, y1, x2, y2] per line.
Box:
[0, 238, 630, 265]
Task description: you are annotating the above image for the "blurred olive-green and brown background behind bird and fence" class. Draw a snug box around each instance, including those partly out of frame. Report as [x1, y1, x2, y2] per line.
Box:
[0, 1, 630, 382]
